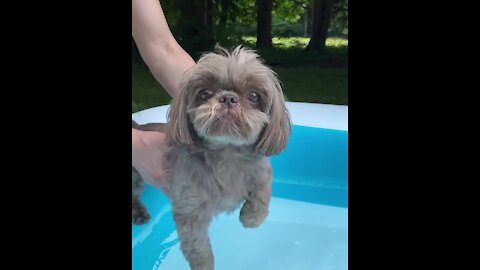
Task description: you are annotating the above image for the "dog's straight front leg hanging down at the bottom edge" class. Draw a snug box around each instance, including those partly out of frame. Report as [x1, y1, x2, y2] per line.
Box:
[173, 209, 214, 270]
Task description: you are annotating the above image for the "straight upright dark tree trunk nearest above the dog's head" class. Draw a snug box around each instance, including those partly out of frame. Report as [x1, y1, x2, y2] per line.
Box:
[256, 0, 273, 48]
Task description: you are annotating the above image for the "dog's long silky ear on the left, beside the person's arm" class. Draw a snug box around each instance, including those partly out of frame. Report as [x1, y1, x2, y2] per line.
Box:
[166, 75, 195, 149]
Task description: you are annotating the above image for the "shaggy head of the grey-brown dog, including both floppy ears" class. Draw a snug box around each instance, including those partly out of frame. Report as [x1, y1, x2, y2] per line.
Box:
[167, 47, 291, 155]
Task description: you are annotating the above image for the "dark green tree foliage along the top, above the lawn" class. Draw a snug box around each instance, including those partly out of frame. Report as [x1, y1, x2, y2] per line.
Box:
[132, 0, 348, 54]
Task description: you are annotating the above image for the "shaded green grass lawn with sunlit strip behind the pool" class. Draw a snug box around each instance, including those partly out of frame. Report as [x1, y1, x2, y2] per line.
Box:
[132, 37, 348, 112]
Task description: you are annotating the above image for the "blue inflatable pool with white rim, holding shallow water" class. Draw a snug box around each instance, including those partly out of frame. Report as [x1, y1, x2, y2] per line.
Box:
[132, 102, 348, 270]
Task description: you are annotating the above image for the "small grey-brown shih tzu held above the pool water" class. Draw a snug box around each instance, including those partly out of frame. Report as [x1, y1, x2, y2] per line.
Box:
[132, 46, 291, 270]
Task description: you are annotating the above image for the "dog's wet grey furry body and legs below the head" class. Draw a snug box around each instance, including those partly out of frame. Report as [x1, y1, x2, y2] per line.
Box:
[132, 123, 272, 270]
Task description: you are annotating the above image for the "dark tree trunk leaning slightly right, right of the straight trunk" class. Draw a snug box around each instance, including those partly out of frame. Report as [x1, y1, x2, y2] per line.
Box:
[306, 0, 333, 52]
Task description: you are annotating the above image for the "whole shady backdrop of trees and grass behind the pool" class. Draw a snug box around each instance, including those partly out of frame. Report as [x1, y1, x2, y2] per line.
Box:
[132, 0, 348, 113]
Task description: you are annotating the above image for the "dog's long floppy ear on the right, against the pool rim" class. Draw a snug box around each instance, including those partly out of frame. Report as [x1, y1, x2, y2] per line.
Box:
[256, 71, 291, 156]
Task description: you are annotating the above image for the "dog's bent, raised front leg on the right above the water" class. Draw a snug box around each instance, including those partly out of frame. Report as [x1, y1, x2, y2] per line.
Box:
[240, 168, 272, 228]
